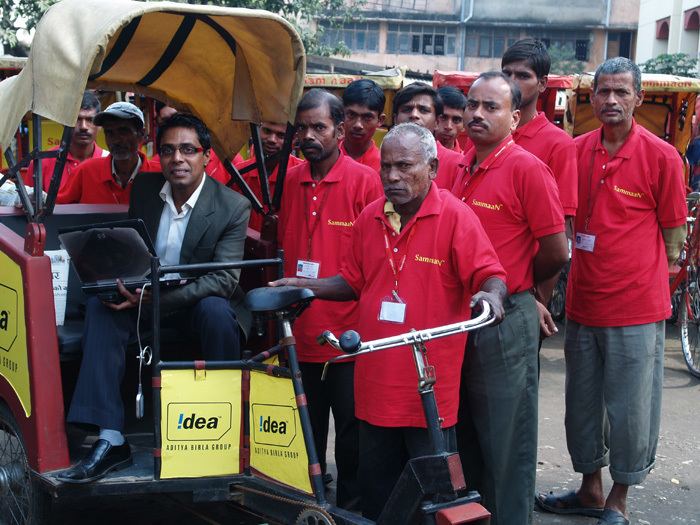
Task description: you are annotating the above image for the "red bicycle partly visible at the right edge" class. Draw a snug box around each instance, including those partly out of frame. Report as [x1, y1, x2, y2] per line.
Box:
[671, 192, 700, 378]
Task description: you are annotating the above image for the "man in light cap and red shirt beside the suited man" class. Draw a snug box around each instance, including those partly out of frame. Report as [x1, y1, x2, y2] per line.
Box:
[56, 102, 160, 204]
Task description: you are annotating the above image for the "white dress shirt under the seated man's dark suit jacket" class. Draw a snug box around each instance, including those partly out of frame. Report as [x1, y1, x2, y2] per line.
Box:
[155, 176, 206, 266]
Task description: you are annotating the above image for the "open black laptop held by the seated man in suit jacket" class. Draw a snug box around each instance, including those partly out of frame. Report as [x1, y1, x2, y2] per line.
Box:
[58, 219, 194, 302]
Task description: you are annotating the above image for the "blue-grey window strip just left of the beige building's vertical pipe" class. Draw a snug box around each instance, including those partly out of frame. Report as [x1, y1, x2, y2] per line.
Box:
[386, 24, 457, 55]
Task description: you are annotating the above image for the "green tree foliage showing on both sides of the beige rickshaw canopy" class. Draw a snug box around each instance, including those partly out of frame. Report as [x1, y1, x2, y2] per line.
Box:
[0, 0, 360, 56]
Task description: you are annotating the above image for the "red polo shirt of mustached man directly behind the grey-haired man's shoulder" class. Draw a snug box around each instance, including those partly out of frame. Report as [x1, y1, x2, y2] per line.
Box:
[452, 136, 564, 294]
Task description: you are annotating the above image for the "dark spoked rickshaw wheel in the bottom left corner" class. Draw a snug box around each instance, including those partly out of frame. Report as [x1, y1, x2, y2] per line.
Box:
[0, 403, 51, 525]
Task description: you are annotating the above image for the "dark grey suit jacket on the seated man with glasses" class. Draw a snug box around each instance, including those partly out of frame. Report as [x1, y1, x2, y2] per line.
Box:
[129, 173, 251, 335]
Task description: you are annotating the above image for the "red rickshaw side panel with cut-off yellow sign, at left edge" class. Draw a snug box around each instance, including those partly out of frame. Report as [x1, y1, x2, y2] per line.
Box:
[0, 224, 69, 472]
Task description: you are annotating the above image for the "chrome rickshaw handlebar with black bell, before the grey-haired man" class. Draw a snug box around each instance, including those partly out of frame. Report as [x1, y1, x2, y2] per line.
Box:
[318, 301, 496, 363]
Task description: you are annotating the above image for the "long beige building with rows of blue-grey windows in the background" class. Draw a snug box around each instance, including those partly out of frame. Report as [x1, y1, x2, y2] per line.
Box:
[319, 0, 639, 72]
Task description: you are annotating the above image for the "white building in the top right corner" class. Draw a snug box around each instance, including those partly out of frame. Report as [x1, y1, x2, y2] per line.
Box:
[637, 0, 700, 63]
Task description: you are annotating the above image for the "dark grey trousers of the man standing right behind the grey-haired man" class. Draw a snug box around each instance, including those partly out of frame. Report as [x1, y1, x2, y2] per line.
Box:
[457, 292, 539, 525]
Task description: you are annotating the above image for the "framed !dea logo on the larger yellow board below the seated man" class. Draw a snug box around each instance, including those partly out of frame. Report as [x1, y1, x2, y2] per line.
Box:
[167, 403, 231, 441]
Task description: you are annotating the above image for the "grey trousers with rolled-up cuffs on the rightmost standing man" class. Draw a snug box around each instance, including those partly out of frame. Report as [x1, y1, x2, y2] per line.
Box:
[564, 321, 665, 485]
